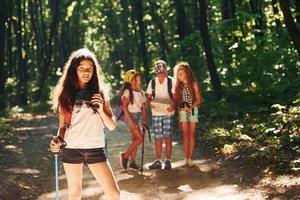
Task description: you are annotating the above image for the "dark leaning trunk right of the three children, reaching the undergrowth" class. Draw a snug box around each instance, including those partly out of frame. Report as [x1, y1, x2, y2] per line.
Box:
[199, 0, 222, 100]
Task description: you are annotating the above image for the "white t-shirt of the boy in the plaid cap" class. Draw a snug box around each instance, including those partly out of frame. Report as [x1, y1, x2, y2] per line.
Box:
[146, 77, 175, 116]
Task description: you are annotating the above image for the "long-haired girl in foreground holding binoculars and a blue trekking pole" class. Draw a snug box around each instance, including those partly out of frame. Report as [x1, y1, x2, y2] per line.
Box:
[50, 49, 120, 200]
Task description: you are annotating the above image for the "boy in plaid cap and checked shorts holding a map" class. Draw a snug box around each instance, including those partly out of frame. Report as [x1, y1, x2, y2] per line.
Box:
[146, 60, 175, 169]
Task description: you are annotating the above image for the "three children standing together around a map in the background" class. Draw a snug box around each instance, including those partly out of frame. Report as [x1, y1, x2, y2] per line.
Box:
[120, 60, 201, 169]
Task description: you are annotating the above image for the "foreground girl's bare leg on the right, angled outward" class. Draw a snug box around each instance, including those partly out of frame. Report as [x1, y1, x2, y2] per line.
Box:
[88, 162, 120, 200]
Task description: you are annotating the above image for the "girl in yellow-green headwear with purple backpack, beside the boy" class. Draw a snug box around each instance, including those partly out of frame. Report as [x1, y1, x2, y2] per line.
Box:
[120, 69, 147, 169]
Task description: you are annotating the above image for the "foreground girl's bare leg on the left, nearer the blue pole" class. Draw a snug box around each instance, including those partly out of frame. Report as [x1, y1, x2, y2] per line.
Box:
[63, 163, 83, 200]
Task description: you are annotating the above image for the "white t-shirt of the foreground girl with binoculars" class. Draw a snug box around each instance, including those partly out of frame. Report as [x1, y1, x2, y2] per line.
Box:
[64, 89, 109, 149]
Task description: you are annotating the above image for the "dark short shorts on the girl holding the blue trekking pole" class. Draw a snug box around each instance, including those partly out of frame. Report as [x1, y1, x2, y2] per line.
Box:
[60, 148, 106, 165]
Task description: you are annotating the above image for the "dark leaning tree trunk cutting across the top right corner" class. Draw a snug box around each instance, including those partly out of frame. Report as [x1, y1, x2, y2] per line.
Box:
[279, 0, 300, 56]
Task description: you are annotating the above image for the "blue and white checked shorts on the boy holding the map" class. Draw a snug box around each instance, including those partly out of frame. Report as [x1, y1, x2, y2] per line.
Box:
[152, 115, 174, 140]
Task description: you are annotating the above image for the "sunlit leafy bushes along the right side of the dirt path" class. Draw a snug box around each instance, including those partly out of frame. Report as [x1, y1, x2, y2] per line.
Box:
[201, 98, 300, 172]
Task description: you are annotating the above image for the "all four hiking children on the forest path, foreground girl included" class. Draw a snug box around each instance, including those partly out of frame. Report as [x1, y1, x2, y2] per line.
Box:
[50, 49, 201, 200]
